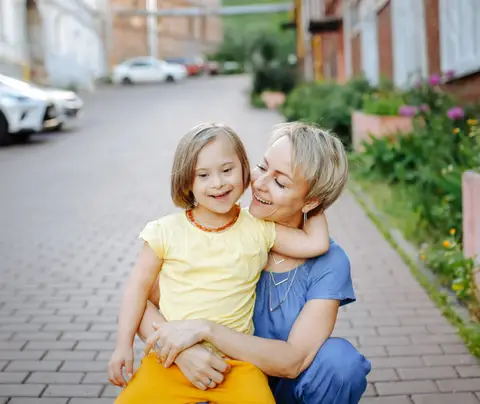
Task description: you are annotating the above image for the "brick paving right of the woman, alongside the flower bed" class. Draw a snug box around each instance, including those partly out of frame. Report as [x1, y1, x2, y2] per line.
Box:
[328, 194, 480, 404]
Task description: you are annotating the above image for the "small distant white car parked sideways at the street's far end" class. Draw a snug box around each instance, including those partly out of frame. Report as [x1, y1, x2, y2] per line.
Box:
[112, 57, 188, 84]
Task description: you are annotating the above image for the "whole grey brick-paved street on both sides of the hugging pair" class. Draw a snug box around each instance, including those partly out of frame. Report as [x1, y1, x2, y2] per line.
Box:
[0, 76, 480, 404]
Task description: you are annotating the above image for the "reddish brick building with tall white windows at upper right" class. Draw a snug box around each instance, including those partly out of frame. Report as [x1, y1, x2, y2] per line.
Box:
[296, 0, 480, 101]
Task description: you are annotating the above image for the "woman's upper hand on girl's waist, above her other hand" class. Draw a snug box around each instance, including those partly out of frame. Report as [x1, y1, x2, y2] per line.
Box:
[145, 320, 208, 368]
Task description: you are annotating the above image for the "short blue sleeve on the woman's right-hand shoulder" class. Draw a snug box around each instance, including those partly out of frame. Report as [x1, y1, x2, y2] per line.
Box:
[307, 246, 355, 306]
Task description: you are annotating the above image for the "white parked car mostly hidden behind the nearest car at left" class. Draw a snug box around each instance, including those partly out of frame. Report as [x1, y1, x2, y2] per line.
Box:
[0, 74, 83, 130]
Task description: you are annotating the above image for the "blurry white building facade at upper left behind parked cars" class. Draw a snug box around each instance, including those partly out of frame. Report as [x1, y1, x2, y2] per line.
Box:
[0, 0, 109, 88]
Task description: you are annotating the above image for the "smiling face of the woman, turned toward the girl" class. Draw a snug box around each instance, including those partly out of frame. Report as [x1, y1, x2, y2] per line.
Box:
[249, 136, 309, 226]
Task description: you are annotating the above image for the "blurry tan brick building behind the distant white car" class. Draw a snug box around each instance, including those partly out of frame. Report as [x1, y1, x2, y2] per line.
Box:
[110, 0, 223, 65]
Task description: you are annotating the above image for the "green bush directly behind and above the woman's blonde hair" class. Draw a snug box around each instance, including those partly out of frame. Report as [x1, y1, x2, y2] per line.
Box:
[283, 78, 374, 148]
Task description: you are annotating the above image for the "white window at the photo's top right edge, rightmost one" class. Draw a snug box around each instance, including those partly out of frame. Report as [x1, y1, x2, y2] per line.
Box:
[439, 0, 480, 77]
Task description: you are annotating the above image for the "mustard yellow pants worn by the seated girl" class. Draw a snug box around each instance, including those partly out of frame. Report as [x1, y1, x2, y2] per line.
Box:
[115, 353, 275, 404]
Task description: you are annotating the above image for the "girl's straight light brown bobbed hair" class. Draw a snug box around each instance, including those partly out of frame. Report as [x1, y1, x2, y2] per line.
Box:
[170, 123, 250, 209]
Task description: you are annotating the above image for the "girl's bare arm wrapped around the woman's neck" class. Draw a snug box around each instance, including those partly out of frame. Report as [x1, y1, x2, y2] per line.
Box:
[272, 213, 330, 258]
